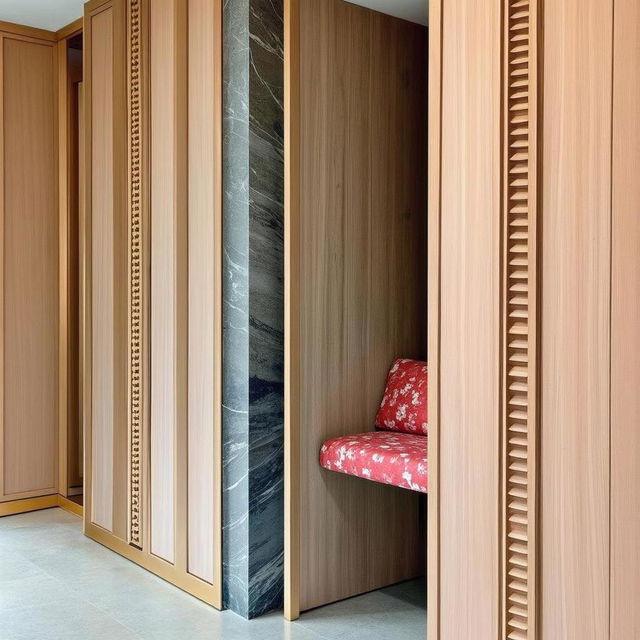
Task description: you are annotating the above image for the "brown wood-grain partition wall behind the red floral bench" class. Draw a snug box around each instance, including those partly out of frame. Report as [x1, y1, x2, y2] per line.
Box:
[285, 0, 427, 619]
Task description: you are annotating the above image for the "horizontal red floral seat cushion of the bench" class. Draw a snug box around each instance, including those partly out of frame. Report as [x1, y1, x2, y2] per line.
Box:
[320, 431, 427, 493]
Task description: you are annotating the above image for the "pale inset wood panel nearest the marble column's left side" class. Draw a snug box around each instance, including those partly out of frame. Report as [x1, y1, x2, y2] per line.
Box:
[187, 0, 221, 582]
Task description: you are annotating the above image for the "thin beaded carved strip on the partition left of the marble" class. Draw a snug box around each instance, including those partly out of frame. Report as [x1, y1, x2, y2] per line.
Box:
[127, 0, 144, 548]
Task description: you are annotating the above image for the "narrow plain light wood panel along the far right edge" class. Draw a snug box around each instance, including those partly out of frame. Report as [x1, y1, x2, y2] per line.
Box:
[611, 0, 640, 639]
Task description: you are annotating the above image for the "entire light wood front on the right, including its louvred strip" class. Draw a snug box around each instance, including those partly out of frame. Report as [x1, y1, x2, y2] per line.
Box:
[428, 0, 640, 640]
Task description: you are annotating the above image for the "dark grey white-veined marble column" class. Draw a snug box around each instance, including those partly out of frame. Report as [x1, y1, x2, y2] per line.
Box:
[223, 0, 284, 618]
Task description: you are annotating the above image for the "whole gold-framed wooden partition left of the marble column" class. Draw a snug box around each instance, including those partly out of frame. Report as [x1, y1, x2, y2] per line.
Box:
[84, 0, 222, 607]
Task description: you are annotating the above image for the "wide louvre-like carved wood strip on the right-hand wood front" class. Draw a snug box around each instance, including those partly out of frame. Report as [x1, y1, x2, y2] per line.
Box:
[502, 0, 538, 640]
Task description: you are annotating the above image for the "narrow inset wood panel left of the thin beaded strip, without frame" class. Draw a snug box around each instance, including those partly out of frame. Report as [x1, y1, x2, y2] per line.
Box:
[90, 8, 115, 531]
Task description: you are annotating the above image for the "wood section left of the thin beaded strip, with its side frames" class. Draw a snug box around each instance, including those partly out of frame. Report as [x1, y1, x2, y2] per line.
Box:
[83, 0, 128, 538]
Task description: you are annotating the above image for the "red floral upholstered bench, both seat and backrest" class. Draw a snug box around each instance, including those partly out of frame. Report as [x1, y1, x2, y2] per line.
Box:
[320, 360, 427, 493]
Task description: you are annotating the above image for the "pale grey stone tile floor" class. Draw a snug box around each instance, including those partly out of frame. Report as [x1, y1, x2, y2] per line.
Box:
[0, 509, 426, 640]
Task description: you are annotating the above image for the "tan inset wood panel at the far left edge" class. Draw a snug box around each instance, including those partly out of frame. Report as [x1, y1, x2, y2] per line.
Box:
[0, 37, 58, 495]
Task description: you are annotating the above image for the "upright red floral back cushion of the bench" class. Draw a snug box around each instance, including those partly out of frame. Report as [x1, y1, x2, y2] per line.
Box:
[376, 360, 427, 435]
